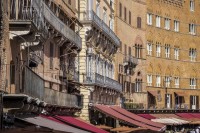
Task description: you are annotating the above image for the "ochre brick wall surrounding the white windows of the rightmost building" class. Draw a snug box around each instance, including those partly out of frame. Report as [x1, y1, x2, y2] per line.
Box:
[146, 0, 200, 108]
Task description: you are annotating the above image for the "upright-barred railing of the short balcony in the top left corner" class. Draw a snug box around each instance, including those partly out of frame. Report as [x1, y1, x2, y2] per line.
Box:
[9, 0, 48, 38]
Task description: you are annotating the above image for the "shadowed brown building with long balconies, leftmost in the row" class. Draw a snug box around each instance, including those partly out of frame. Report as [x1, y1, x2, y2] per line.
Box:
[1, 0, 82, 115]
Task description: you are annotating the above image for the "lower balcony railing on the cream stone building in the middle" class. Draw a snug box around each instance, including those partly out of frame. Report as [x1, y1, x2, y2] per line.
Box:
[84, 73, 122, 92]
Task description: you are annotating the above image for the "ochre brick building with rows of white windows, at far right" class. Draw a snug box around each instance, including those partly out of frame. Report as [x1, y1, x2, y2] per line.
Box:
[145, 0, 200, 109]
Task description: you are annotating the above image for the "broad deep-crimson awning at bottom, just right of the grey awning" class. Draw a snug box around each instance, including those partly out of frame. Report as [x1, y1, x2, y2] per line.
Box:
[55, 116, 108, 133]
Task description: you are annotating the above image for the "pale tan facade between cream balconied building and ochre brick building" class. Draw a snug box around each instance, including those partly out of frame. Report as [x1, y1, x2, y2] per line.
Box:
[115, 0, 147, 108]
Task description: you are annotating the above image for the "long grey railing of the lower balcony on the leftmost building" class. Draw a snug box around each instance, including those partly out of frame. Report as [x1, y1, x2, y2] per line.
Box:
[23, 67, 81, 107]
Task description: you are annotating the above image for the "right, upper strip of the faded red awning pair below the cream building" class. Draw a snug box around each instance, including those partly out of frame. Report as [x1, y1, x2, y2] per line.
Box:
[111, 106, 165, 129]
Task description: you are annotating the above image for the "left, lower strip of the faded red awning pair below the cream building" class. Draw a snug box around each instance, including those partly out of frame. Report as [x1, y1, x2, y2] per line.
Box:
[94, 105, 164, 131]
